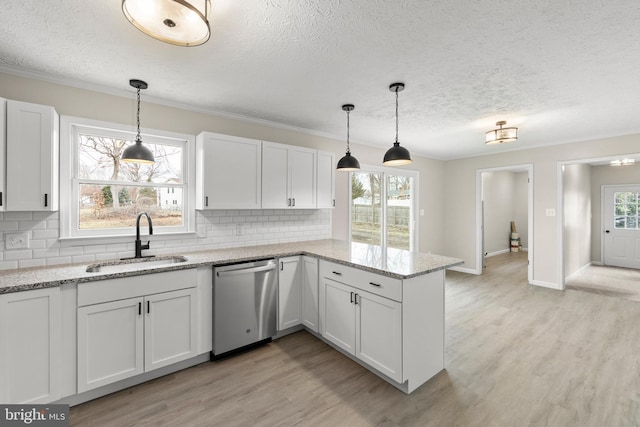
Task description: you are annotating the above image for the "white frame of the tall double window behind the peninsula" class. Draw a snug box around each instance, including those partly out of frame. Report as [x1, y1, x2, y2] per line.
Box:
[348, 165, 420, 251]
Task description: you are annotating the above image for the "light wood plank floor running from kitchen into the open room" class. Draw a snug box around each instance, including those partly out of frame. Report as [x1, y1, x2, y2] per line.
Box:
[71, 253, 640, 427]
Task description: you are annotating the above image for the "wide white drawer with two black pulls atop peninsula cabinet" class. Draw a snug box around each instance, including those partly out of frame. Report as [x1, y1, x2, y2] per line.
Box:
[320, 260, 402, 302]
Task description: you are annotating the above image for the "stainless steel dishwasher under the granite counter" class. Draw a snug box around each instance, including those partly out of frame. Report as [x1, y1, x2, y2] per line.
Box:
[212, 259, 277, 357]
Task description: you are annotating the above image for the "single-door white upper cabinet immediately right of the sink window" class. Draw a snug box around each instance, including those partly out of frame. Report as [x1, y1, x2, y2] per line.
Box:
[196, 132, 262, 209]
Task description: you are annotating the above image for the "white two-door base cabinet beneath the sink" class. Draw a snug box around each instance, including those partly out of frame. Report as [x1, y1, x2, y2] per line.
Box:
[78, 269, 198, 393]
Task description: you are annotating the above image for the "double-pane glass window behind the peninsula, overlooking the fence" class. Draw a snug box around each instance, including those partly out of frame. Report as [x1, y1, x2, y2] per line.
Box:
[350, 167, 418, 250]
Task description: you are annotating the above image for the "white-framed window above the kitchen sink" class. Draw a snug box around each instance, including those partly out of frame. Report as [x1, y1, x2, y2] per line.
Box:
[60, 117, 194, 238]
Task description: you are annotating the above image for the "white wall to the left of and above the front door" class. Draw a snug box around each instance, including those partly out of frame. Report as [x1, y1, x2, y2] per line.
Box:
[591, 165, 640, 263]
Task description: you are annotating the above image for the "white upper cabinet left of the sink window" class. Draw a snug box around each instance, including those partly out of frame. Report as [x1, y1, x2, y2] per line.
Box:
[4, 100, 60, 211]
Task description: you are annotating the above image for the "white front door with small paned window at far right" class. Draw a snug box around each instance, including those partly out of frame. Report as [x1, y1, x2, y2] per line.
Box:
[602, 185, 640, 268]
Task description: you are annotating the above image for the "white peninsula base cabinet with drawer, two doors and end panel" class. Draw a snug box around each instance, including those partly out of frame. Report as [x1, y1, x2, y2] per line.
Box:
[319, 260, 444, 393]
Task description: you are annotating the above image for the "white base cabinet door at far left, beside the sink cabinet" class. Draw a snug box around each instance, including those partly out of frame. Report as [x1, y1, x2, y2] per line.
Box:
[0, 288, 61, 403]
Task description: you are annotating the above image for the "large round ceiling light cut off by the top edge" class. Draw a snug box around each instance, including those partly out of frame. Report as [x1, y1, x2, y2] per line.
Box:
[122, 0, 211, 46]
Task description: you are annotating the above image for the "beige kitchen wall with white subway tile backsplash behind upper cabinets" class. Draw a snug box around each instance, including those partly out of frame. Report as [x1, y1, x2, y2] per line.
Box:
[0, 73, 445, 269]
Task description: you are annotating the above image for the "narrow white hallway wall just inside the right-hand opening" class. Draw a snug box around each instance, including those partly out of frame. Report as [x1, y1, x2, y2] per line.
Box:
[562, 164, 592, 277]
